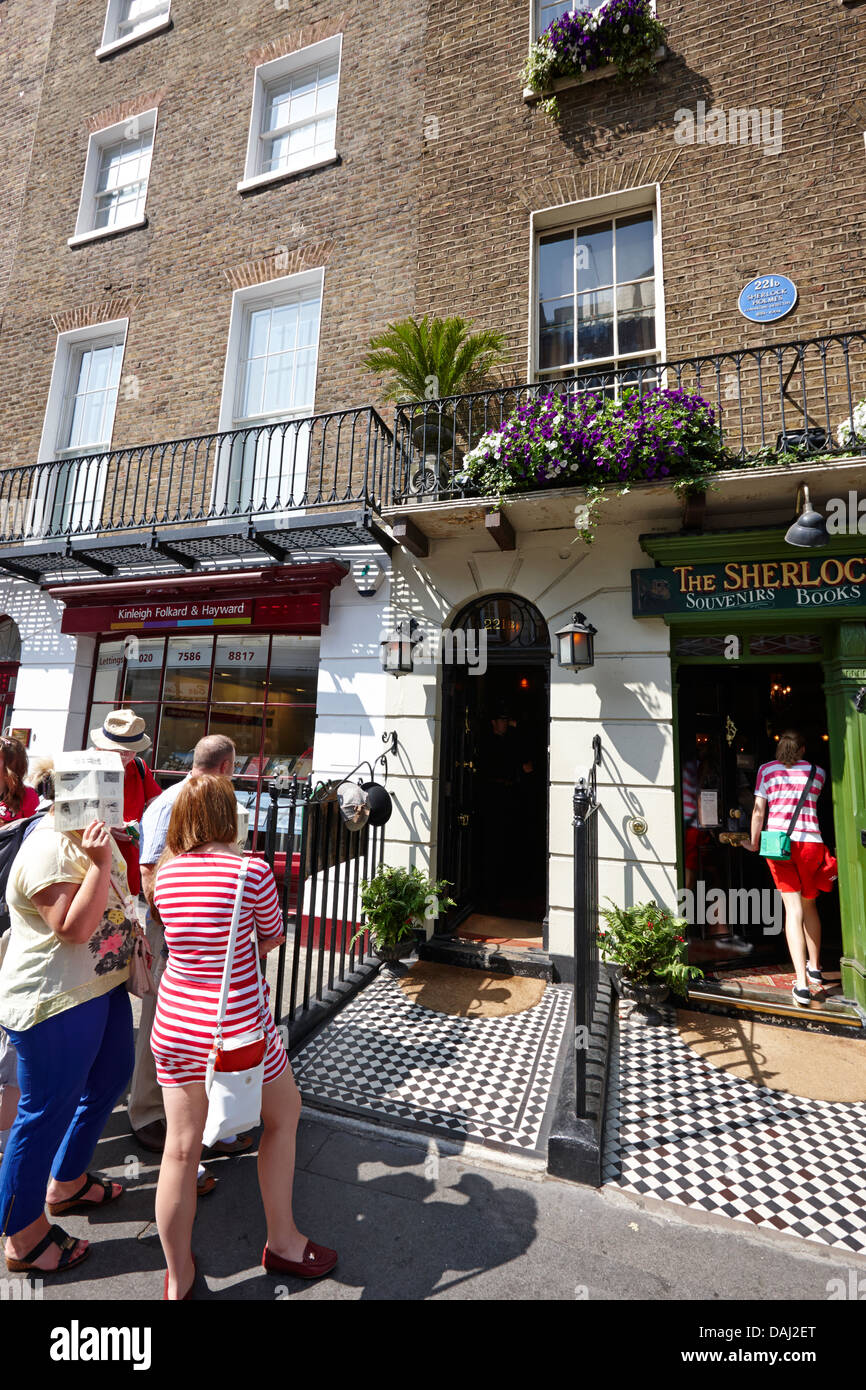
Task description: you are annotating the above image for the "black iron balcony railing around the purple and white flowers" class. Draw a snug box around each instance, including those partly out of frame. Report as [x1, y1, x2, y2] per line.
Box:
[388, 331, 866, 505]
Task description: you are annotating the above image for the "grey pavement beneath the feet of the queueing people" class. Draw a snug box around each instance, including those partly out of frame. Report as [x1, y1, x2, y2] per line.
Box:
[16, 1109, 866, 1301]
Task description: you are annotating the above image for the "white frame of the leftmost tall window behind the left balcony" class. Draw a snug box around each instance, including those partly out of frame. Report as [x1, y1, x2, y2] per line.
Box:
[26, 318, 129, 535]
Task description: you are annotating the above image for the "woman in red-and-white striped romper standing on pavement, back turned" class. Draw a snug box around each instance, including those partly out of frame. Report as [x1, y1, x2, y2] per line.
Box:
[152, 774, 336, 1298]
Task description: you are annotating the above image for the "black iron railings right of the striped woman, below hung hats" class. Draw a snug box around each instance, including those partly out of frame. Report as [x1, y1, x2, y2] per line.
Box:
[264, 778, 385, 1048]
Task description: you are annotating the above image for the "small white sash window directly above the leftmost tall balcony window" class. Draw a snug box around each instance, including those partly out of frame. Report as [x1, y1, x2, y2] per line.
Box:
[68, 110, 156, 246]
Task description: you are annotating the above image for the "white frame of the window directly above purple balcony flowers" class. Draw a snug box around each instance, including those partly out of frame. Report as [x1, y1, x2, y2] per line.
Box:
[527, 183, 667, 385]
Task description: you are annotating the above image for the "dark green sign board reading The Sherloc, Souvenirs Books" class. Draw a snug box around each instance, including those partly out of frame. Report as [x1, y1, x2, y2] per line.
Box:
[631, 555, 866, 617]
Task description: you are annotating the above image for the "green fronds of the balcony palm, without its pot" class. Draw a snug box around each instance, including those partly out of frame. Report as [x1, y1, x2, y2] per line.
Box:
[364, 314, 505, 403]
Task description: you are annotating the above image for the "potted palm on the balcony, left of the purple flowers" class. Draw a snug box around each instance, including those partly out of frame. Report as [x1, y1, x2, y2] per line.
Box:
[364, 314, 505, 491]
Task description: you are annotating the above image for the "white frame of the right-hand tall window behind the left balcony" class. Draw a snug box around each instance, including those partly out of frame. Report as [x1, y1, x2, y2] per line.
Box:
[211, 265, 325, 510]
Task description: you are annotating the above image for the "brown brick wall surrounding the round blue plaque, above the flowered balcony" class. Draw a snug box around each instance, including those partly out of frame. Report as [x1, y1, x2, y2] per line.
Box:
[417, 0, 866, 378]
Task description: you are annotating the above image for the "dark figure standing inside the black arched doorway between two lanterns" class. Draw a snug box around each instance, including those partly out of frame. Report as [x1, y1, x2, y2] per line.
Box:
[478, 705, 537, 913]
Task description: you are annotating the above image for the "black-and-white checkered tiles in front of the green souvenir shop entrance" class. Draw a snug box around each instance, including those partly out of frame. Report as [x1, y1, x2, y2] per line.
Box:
[605, 1009, 866, 1254]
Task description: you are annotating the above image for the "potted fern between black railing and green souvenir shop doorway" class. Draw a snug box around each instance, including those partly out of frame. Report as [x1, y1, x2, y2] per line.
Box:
[598, 898, 703, 1022]
